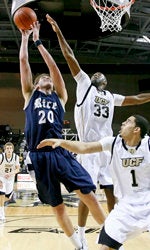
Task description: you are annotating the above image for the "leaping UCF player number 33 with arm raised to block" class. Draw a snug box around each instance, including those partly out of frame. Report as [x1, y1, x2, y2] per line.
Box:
[46, 15, 150, 249]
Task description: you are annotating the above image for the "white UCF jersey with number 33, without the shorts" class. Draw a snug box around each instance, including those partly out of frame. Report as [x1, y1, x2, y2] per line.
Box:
[74, 70, 125, 142]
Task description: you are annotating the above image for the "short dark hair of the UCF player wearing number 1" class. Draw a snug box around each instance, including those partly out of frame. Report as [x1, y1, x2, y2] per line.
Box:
[133, 115, 150, 138]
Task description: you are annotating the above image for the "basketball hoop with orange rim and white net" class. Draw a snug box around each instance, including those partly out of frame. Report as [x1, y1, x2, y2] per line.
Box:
[90, 0, 135, 32]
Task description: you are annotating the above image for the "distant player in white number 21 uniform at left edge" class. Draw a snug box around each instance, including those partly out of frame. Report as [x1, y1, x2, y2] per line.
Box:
[0, 142, 20, 222]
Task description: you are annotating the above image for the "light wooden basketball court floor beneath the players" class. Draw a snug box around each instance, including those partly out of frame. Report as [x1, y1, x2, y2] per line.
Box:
[0, 185, 150, 250]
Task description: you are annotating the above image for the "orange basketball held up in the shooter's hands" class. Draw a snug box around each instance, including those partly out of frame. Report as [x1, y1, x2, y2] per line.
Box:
[13, 7, 37, 30]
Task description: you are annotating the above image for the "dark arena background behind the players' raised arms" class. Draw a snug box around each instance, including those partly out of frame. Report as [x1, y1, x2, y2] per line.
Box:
[0, 0, 150, 133]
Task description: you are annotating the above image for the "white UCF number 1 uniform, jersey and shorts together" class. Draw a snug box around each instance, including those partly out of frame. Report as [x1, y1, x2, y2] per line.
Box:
[100, 136, 150, 243]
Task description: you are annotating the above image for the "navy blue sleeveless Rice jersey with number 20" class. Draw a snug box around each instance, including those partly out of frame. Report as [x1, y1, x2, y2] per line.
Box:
[25, 90, 64, 151]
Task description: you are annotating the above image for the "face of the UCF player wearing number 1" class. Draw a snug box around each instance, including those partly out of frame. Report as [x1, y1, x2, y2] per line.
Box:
[119, 116, 136, 139]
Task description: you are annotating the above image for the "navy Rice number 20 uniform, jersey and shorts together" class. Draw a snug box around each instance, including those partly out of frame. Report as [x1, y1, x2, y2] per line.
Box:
[25, 90, 96, 207]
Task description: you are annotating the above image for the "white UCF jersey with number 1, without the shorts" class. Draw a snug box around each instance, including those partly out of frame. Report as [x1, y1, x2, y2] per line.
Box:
[100, 136, 150, 205]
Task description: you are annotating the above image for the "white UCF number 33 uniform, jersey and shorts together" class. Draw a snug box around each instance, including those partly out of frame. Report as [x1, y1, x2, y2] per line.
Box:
[74, 70, 125, 186]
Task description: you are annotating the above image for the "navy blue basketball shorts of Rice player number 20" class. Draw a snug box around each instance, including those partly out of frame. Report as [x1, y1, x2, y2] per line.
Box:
[30, 147, 96, 207]
